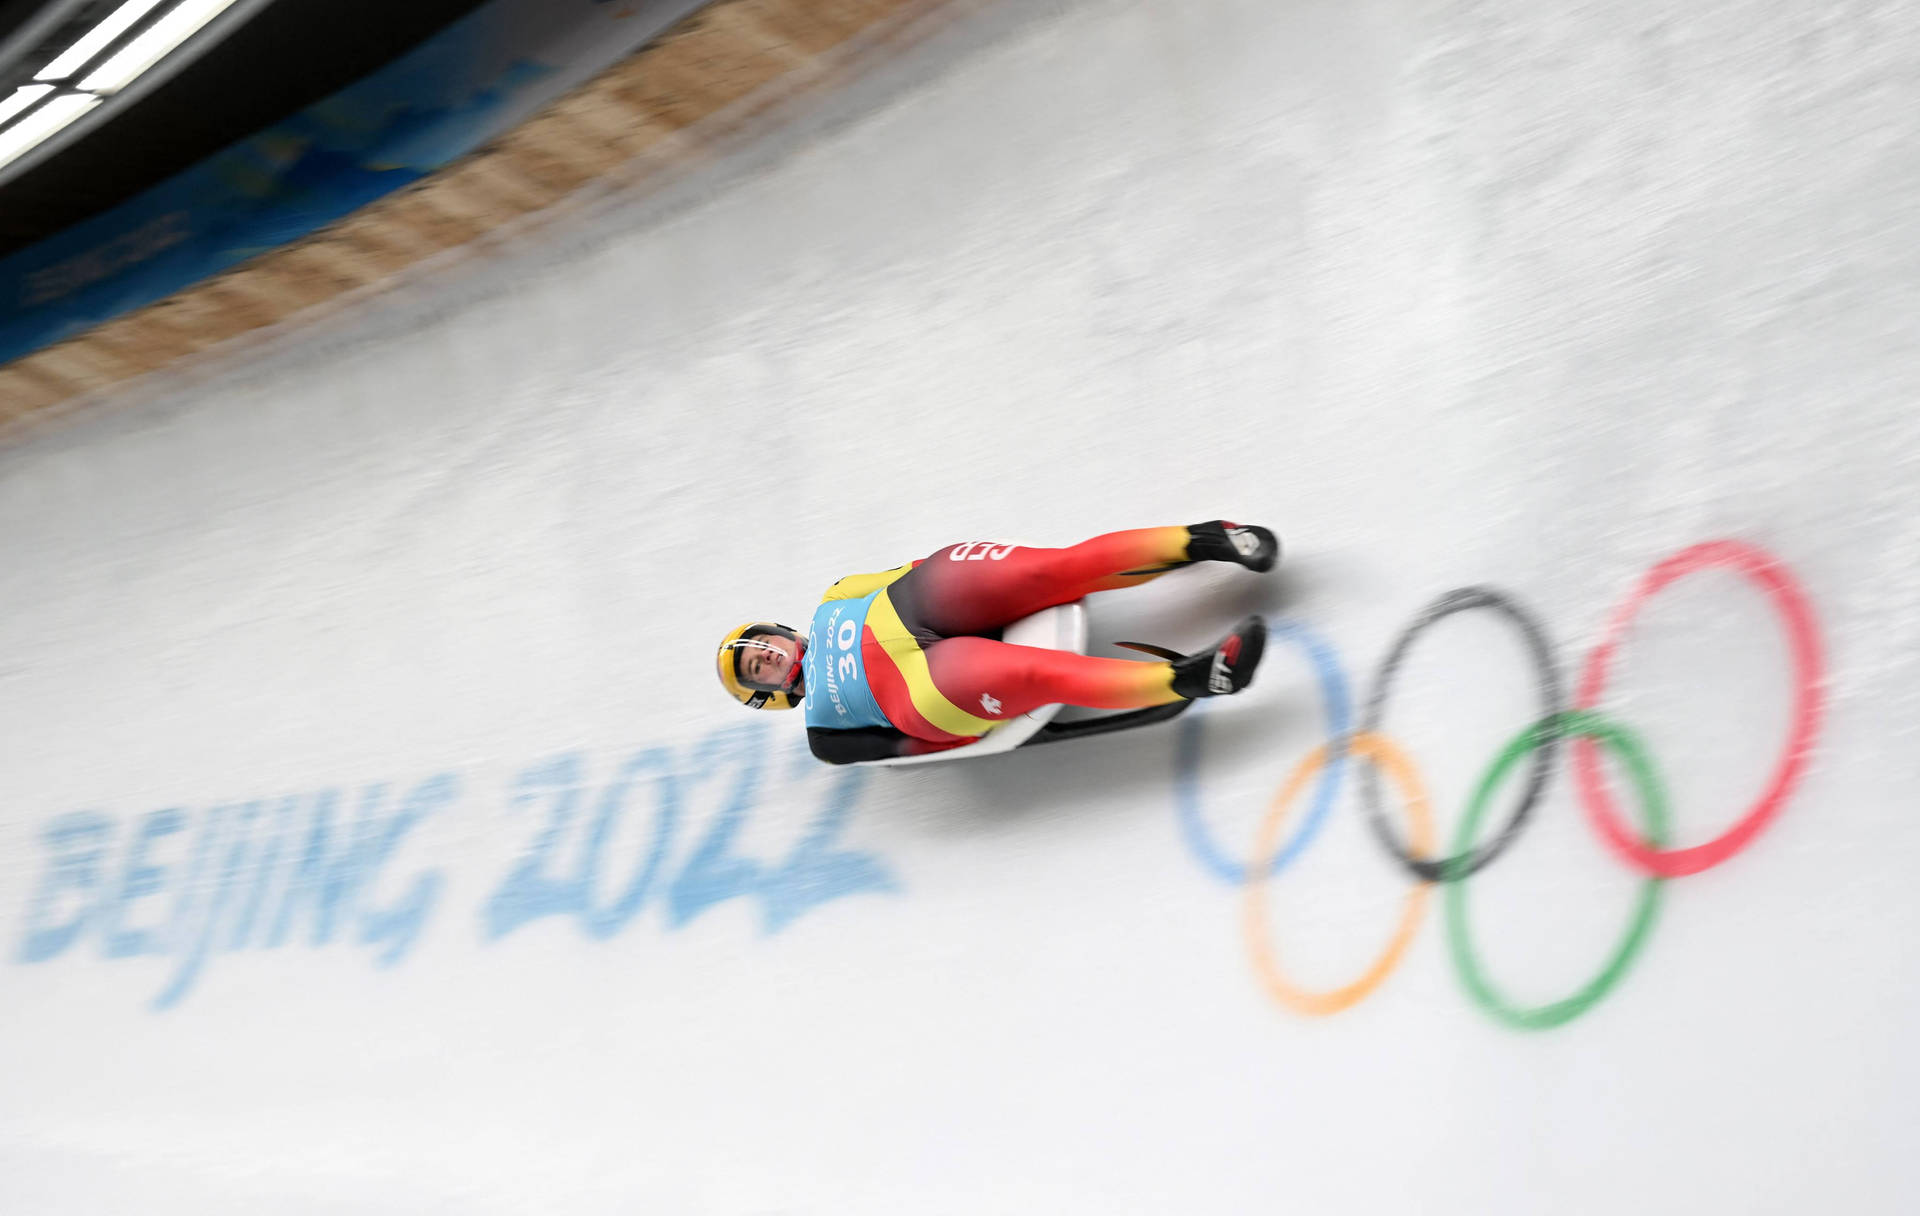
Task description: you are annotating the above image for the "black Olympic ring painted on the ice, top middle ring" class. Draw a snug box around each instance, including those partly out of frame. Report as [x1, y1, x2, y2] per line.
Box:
[1359, 586, 1565, 882]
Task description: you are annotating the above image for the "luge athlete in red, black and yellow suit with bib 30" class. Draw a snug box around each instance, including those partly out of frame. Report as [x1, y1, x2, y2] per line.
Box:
[718, 519, 1281, 765]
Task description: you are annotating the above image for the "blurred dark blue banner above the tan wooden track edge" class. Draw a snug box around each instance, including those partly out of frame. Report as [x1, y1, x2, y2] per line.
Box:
[0, 0, 707, 363]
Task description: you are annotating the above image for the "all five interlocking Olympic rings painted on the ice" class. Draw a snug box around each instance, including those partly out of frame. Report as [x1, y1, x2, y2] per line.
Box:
[1175, 540, 1826, 1030]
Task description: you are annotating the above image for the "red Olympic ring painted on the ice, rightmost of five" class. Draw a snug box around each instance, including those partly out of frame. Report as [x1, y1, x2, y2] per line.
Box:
[1572, 540, 1826, 878]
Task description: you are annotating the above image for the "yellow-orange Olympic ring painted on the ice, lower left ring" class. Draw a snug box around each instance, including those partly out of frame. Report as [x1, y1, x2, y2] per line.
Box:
[1244, 734, 1434, 1016]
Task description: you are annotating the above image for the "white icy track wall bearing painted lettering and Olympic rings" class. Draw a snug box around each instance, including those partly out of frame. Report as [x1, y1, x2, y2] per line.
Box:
[0, 0, 1920, 1216]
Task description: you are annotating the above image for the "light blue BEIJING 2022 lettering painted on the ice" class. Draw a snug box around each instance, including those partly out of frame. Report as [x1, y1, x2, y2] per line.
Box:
[15, 722, 899, 1010]
